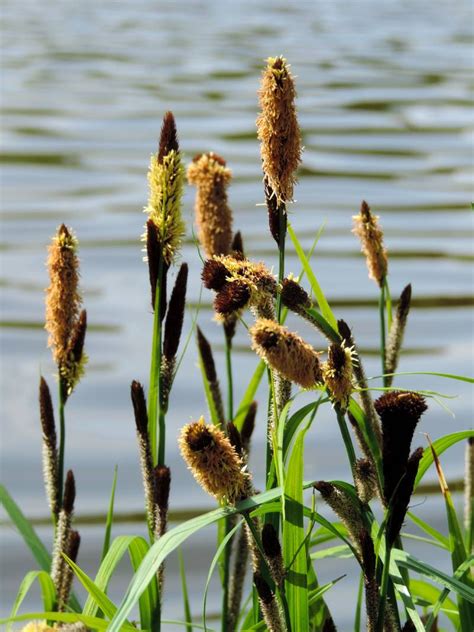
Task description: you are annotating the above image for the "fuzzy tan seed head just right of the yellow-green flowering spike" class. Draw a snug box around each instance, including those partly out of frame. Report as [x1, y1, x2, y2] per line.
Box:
[188, 152, 232, 257]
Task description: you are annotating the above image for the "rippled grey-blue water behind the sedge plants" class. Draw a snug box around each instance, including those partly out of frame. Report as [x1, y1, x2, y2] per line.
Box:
[1, 0, 473, 630]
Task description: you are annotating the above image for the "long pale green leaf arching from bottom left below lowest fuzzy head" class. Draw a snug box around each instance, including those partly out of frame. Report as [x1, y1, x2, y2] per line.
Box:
[110, 482, 313, 632]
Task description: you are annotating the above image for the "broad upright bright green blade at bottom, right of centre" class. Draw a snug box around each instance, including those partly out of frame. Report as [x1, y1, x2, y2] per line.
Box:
[282, 427, 309, 630]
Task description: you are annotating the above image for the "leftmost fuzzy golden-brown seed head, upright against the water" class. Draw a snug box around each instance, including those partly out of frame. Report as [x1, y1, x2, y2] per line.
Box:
[45, 224, 82, 367]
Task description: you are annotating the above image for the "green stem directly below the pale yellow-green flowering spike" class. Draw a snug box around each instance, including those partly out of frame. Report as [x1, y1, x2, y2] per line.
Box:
[148, 255, 165, 465]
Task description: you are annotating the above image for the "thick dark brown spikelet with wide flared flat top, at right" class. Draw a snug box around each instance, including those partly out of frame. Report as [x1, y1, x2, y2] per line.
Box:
[374, 391, 427, 503]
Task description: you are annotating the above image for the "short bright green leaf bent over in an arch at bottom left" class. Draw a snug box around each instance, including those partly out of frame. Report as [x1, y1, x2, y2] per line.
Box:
[83, 535, 158, 628]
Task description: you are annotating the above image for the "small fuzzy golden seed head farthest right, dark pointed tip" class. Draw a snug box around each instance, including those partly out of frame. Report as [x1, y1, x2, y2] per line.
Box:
[352, 201, 388, 287]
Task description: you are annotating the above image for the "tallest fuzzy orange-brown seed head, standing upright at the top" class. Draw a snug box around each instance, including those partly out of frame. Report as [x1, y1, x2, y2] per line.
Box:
[257, 57, 301, 202]
